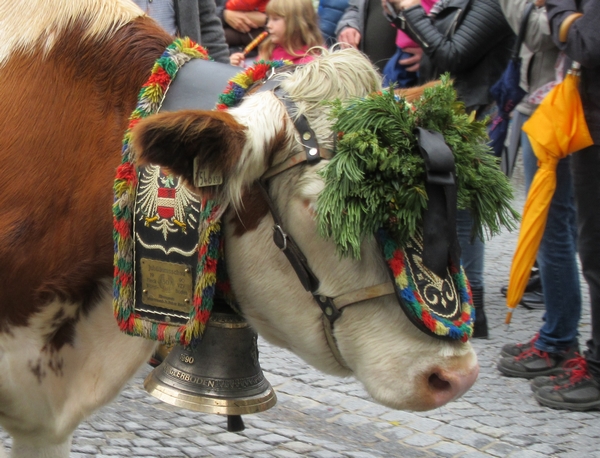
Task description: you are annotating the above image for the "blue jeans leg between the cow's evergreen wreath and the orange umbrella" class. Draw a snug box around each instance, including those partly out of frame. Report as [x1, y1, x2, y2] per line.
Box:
[456, 210, 485, 289]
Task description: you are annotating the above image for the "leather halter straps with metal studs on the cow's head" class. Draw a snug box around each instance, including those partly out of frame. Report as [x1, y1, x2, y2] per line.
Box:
[252, 72, 395, 369]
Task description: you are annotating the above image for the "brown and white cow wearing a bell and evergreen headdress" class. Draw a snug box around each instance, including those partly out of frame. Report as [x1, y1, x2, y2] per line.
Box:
[0, 0, 478, 458]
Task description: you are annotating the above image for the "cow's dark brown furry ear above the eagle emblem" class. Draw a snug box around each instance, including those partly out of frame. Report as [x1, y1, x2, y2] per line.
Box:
[132, 110, 246, 183]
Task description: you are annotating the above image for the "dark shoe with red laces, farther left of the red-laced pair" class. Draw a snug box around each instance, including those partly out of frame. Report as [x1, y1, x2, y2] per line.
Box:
[497, 347, 578, 379]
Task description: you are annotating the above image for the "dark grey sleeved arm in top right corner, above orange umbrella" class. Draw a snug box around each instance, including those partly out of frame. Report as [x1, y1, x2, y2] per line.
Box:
[546, 0, 600, 68]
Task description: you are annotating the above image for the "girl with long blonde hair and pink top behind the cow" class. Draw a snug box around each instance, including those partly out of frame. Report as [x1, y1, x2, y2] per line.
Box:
[229, 0, 323, 66]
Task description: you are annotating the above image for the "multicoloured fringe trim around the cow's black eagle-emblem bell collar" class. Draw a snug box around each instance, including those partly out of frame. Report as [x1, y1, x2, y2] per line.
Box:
[113, 38, 289, 346]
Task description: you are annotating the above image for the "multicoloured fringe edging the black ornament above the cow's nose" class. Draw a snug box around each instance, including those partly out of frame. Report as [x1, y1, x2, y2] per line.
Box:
[378, 230, 475, 342]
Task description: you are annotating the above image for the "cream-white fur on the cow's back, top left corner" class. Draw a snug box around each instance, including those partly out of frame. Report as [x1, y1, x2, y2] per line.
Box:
[0, 0, 144, 65]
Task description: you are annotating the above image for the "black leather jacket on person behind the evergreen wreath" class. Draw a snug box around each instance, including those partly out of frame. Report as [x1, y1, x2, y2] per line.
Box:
[397, 0, 515, 109]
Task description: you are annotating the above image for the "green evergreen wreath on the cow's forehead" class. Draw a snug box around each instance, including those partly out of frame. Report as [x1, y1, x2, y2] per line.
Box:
[317, 74, 519, 258]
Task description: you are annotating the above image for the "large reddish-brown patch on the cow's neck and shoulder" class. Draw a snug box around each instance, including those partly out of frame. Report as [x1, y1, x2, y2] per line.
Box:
[0, 18, 172, 330]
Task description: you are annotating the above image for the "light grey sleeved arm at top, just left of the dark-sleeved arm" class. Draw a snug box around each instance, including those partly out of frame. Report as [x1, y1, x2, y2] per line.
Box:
[499, 0, 556, 53]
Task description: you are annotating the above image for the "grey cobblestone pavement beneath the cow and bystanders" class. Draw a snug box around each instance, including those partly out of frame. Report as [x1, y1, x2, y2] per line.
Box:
[0, 163, 600, 458]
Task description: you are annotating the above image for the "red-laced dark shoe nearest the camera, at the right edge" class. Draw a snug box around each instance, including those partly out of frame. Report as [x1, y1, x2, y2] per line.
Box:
[533, 358, 600, 411]
